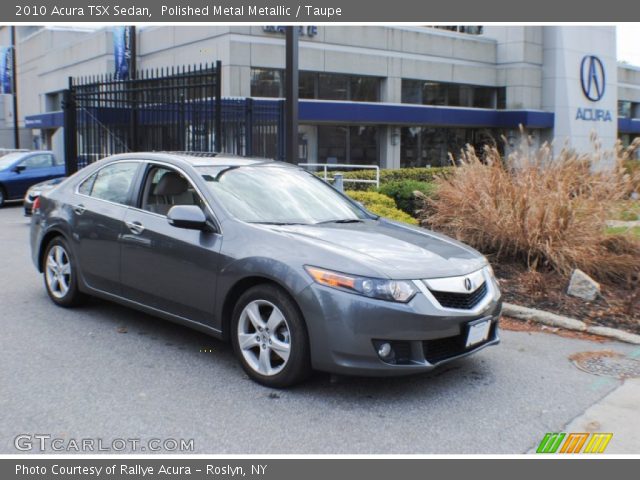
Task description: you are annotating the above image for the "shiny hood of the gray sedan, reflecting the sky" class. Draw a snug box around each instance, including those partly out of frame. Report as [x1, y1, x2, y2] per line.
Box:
[272, 219, 486, 280]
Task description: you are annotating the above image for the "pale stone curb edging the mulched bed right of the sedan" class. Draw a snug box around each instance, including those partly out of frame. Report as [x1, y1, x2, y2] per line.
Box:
[502, 303, 640, 345]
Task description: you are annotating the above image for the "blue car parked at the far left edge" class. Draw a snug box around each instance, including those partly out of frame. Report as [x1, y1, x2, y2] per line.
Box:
[0, 150, 65, 207]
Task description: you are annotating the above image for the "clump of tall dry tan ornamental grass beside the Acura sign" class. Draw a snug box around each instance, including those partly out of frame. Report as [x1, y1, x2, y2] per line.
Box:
[420, 131, 640, 281]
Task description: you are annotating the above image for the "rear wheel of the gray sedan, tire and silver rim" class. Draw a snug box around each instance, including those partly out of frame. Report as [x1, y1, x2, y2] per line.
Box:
[43, 237, 84, 307]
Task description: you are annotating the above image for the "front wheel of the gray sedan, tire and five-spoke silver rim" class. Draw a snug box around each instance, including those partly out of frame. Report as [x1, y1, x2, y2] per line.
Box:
[231, 284, 311, 388]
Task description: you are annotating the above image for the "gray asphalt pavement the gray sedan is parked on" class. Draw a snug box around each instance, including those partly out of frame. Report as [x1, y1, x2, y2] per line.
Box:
[0, 205, 637, 454]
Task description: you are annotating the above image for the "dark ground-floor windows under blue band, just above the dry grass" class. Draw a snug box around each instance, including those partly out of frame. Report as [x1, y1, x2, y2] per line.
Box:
[400, 126, 503, 167]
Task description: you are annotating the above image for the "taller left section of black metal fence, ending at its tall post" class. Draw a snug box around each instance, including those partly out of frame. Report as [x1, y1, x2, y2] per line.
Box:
[64, 62, 222, 173]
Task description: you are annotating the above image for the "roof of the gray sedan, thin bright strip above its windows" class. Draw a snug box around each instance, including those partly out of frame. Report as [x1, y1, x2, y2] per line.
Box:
[105, 152, 295, 171]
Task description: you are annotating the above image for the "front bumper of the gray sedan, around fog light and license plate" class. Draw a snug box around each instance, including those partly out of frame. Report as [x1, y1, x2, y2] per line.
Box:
[297, 278, 502, 376]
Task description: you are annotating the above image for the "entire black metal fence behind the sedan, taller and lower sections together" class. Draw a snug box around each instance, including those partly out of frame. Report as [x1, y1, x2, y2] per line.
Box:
[63, 62, 285, 173]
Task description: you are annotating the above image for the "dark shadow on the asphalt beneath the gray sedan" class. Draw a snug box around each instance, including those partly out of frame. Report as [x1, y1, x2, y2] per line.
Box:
[81, 298, 494, 402]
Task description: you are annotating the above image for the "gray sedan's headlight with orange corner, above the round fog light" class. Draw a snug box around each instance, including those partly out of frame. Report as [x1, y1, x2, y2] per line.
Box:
[304, 266, 418, 303]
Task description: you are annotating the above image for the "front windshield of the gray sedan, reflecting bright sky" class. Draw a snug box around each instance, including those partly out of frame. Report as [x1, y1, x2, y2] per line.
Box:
[198, 166, 368, 224]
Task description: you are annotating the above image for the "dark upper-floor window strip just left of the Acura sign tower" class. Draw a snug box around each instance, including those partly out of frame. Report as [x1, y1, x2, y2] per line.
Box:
[402, 79, 506, 109]
